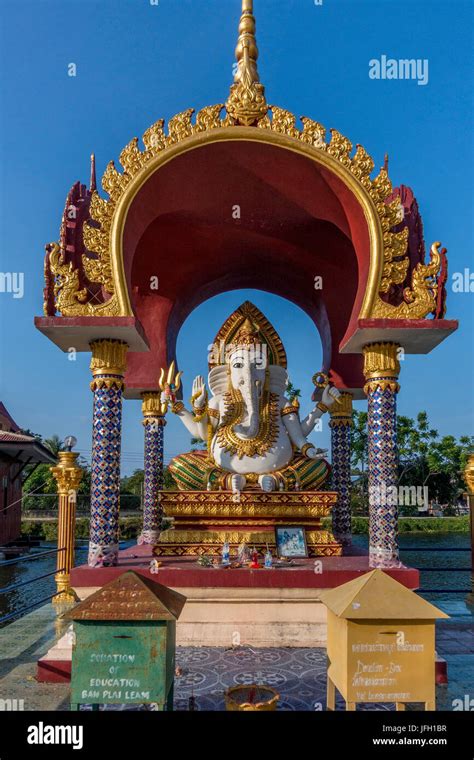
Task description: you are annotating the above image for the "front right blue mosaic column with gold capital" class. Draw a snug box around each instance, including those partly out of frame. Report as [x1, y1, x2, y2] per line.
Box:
[364, 343, 400, 568]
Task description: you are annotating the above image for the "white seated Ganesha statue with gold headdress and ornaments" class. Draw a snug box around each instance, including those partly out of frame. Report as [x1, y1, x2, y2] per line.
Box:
[169, 301, 339, 493]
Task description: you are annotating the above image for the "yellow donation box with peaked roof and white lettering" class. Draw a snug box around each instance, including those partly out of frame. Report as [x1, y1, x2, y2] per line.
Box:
[321, 570, 449, 710]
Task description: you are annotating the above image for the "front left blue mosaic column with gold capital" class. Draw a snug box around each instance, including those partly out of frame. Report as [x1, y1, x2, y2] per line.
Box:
[89, 340, 127, 567]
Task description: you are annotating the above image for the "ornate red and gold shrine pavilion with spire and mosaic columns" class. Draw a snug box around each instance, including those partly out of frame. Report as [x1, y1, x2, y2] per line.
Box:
[35, 0, 457, 585]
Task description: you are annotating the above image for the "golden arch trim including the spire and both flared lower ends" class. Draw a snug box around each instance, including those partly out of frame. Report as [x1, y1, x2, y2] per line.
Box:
[45, 0, 448, 326]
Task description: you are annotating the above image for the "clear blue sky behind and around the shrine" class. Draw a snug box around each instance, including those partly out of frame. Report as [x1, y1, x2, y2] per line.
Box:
[0, 0, 474, 472]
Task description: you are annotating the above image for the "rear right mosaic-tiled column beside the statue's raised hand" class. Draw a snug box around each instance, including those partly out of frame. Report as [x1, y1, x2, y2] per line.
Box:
[329, 393, 352, 546]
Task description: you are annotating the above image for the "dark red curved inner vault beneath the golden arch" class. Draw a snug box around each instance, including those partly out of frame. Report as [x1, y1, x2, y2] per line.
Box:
[112, 128, 383, 396]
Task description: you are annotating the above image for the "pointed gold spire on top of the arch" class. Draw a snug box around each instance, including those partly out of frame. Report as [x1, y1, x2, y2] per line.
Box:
[226, 0, 268, 127]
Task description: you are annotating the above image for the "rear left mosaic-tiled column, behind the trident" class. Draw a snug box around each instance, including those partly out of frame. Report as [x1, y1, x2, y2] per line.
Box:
[138, 392, 166, 544]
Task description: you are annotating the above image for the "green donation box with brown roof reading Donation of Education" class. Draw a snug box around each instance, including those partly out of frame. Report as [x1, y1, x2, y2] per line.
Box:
[66, 571, 186, 710]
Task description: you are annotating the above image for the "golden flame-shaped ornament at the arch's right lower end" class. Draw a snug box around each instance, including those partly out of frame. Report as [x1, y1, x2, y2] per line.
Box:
[371, 240, 441, 319]
